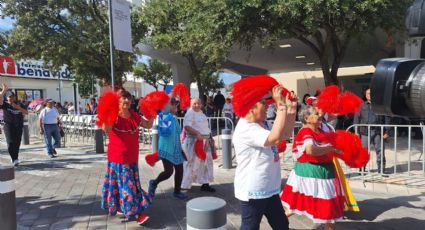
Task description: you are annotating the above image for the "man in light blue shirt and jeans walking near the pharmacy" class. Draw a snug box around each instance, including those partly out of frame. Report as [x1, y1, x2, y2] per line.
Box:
[38, 99, 61, 158]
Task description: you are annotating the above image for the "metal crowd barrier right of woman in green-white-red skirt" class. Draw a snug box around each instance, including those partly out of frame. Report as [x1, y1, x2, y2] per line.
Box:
[345, 124, 425, 177]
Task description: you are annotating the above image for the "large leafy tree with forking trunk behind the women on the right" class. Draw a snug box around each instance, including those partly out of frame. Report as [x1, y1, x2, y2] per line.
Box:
[175, 0, 413, 85]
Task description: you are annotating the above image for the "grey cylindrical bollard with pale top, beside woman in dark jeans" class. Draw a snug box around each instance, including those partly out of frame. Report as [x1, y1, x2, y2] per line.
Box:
[186, 196, 226, 230]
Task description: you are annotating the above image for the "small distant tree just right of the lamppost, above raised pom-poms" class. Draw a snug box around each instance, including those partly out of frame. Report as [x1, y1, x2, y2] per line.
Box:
[133, 59, 173, 91]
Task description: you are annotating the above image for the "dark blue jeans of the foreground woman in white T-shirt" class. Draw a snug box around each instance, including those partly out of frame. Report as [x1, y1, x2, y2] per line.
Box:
[240, 194, 289, 230]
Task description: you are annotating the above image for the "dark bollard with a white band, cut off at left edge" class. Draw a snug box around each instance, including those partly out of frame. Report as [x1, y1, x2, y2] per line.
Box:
[0, 165, 17, 230]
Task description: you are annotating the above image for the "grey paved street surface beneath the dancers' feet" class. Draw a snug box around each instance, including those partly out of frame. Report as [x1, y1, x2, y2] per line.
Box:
[0, 139, 425, 230]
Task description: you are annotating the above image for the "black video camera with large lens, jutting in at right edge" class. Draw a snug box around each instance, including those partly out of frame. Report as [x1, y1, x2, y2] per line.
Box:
[371, 0, 425, 119]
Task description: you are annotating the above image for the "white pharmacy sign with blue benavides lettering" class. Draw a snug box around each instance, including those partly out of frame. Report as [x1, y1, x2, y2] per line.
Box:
[0, 56, 71, 80]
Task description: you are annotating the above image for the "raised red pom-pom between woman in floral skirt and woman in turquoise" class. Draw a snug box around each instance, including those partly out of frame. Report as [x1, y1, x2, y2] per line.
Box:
[139, 91, 170, 119]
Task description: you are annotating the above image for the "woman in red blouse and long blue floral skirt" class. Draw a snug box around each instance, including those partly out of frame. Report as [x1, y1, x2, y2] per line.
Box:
[101, 90, 153, 224]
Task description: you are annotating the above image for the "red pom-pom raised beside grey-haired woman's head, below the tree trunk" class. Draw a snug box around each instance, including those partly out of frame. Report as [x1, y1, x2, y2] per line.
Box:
[316, 85, 363, 115]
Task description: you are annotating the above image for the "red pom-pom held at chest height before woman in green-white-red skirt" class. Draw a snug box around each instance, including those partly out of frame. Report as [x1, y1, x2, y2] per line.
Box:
[332, 130, 369, 168]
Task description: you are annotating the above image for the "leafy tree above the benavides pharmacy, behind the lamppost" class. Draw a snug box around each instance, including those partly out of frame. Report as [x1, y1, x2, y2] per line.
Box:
[0, 0, 146, 84]
